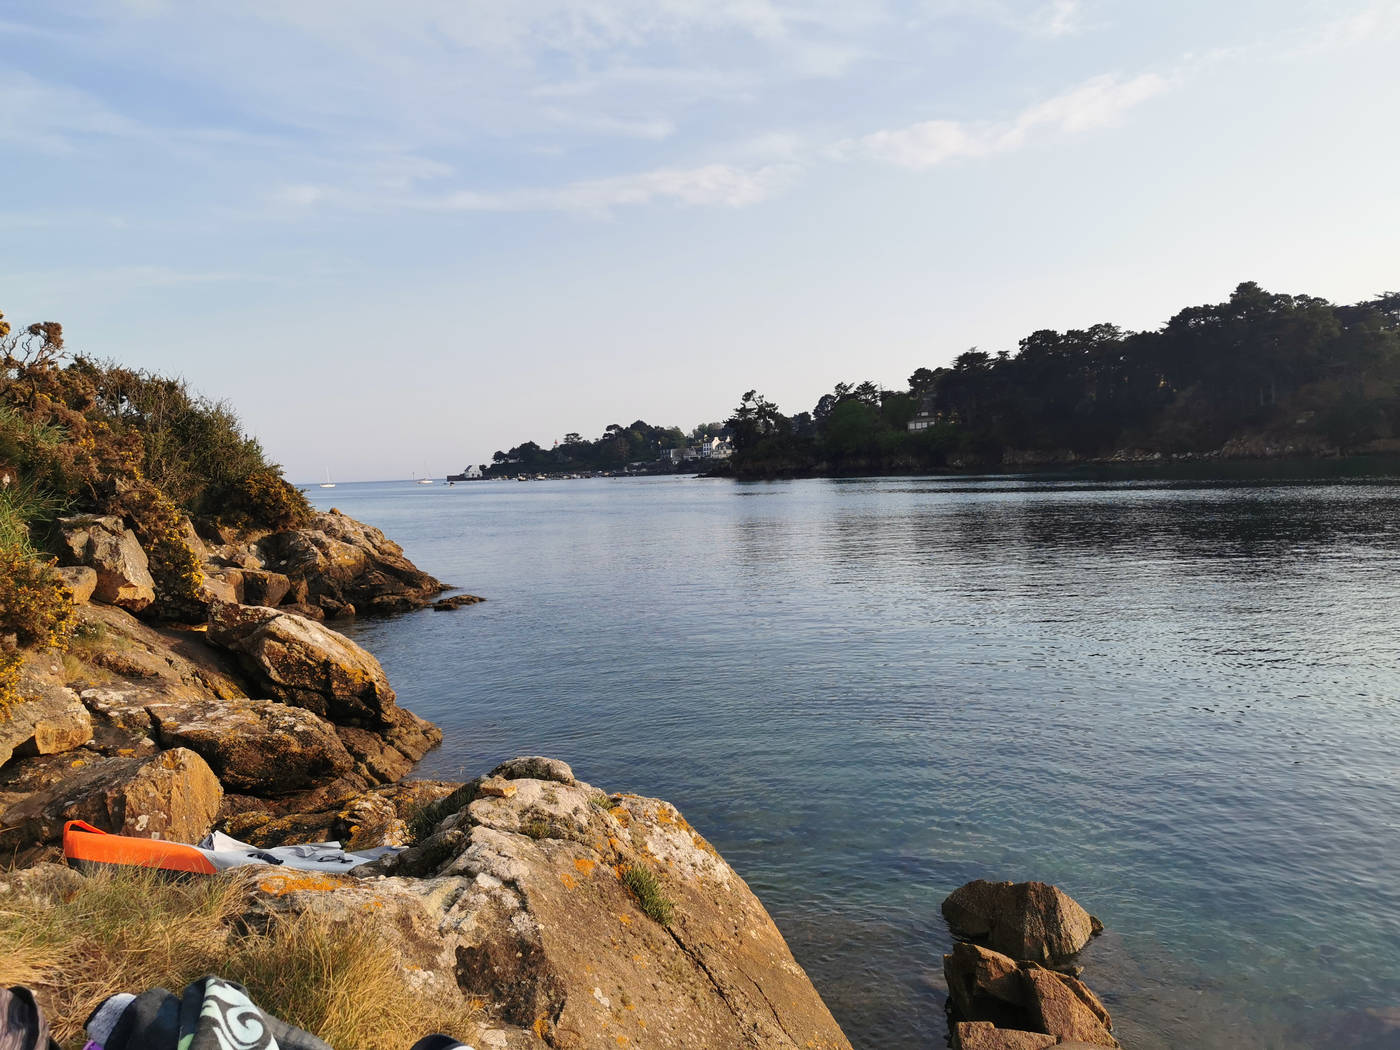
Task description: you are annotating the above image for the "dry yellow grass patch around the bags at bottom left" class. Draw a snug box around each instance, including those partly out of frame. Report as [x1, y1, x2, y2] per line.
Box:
[0, 869, 480, 1050]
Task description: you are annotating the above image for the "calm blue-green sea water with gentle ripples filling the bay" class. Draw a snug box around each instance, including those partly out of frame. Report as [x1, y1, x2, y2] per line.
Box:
[309, 477, 1400, 1050]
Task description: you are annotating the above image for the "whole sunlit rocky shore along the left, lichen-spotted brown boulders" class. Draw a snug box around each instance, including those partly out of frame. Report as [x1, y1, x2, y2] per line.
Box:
[0, 511, 850, 1050]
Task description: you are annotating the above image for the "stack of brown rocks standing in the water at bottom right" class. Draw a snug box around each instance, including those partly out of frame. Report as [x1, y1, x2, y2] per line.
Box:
[942, 879, 1119, 1050]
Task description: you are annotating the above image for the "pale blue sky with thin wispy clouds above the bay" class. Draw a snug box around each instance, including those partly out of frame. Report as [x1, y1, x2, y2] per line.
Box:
[0, 0, 1400, 482]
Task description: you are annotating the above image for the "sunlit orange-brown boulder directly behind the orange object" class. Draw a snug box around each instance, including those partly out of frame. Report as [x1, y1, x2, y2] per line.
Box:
[0, 748, 224, 851]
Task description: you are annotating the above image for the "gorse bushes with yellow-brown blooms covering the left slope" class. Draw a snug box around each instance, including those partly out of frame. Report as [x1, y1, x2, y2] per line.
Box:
[0, 303, 311, 703]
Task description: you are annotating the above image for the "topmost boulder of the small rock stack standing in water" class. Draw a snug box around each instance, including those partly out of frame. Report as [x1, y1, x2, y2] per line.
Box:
[942, 879, 1103, 962]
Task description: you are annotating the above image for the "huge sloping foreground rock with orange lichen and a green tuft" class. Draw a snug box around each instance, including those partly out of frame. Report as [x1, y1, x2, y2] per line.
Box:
[241, 760, 850, 1050]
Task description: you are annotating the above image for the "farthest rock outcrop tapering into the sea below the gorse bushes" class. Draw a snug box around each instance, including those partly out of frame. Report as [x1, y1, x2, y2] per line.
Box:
[259, 510, 445, 616]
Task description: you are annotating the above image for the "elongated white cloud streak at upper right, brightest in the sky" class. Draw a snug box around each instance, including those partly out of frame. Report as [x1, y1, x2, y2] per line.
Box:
[834, 73, 1170, 168]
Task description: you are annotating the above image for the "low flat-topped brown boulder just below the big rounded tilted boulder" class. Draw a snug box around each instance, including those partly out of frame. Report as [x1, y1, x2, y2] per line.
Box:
[147, 699, 354, 797]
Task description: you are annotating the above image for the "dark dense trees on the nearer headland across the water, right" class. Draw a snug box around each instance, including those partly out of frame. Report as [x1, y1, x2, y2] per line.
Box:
[728, 283, 1400, 477]
